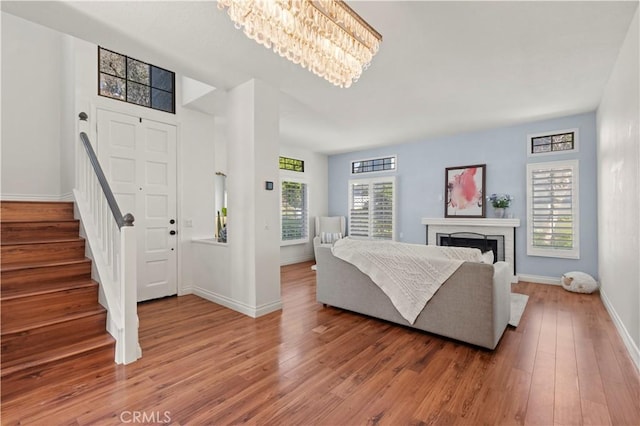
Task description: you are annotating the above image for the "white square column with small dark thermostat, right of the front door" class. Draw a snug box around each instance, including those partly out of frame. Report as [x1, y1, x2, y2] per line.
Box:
[210, 80, 281, 317]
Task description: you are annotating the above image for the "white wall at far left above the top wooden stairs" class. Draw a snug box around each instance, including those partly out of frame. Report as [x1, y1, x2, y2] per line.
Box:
[1, 13, 62, 200]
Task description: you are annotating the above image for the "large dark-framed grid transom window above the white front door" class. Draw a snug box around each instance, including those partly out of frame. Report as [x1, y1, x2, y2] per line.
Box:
[98, 47, 176, 113]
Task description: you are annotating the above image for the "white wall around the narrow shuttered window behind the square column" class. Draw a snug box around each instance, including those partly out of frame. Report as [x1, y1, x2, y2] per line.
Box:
[280, 144, 329, 265]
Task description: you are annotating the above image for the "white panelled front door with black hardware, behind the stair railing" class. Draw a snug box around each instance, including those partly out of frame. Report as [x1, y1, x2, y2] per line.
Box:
[97, 109, 178, 301]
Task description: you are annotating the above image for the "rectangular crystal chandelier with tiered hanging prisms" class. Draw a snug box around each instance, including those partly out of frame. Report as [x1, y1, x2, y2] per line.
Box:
[218, 0, 382, 87]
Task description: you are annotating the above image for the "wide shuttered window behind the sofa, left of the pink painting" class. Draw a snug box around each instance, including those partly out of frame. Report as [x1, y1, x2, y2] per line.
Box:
[349, 178, 395, 240]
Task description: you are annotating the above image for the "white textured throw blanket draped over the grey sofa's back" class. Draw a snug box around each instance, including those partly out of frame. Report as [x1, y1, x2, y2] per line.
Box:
[332, 238, 481, 324]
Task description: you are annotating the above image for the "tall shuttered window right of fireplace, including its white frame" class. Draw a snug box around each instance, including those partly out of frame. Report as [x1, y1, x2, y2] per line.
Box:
[527, 160, 580, 259]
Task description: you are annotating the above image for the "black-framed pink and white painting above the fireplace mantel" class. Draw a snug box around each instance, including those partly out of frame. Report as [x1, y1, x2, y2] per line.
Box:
[444, 164, 486, 217]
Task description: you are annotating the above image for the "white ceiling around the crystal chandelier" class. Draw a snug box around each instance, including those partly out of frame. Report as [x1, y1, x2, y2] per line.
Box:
[2, 1, 638, 154]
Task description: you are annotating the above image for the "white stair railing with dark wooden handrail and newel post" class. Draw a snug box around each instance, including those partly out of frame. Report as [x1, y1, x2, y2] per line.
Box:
[73, 113, 142, 364]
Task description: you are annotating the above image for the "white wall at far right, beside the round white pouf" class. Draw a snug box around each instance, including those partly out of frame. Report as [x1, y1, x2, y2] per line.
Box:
[597, 10, 640, 369]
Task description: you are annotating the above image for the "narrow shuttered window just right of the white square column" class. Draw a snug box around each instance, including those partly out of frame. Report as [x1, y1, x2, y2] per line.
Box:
[280, 180, 309, 244]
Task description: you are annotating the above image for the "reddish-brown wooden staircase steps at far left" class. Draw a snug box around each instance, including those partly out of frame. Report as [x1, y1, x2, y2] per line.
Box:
[0, 201, 115, 398]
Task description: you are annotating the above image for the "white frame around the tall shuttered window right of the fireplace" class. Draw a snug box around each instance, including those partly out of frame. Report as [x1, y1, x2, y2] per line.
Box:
[527, 160, 580, 259]
